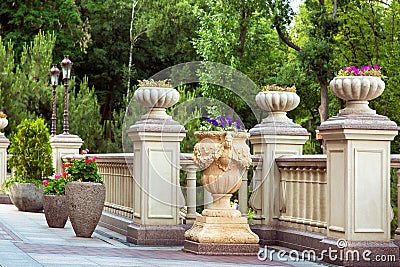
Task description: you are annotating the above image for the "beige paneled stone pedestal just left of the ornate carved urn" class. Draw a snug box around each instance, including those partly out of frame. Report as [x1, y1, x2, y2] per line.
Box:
[127, 117, 186, 245]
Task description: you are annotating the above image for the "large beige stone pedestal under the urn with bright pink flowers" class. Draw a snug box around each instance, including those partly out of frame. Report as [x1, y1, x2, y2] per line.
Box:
[319, 114, 399, 266]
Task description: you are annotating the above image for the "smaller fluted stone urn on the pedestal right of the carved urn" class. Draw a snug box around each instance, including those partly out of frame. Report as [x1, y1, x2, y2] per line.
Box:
[256, 91, 300, 122]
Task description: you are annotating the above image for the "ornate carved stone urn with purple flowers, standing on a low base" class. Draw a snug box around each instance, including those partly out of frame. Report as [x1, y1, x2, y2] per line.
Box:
[193, 131, 251, 217]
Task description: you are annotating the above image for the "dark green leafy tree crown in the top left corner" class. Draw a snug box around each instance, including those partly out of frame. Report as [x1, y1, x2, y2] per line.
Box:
[0, 0, 89, 62]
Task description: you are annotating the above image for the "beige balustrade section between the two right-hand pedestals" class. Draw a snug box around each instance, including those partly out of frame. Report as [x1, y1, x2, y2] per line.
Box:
[275, 155, 327, 233]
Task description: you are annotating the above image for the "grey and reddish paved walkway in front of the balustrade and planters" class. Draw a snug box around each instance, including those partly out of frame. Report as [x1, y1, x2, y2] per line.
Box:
[0, 204, 332, 267]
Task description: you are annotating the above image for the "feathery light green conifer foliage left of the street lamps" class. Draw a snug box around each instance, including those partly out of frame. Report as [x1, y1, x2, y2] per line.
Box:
[0, 32, 55, 134]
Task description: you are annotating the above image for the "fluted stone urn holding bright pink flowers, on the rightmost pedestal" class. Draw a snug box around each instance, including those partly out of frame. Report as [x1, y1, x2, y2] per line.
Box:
[329, 76, 385, 115]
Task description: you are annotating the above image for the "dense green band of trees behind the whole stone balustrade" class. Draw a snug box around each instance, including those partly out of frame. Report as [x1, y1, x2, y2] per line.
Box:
[0, 0, 400, 153]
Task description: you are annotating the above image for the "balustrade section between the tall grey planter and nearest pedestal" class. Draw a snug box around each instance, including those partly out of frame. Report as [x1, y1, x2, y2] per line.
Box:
[62, 153, 135, 219]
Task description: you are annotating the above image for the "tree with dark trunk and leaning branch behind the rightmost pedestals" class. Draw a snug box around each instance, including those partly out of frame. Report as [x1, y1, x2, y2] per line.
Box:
[267, 0, 339, 122]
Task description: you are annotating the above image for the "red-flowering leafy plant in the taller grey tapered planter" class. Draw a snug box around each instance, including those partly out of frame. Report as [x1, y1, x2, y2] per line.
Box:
[63, 149, 103, 183]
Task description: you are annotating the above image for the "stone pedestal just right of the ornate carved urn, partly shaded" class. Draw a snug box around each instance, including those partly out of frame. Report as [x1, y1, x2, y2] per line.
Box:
[249, 119, 309, 229]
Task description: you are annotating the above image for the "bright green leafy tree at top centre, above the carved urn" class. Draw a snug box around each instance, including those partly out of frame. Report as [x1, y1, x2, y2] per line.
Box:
[193, 0, 285, 126]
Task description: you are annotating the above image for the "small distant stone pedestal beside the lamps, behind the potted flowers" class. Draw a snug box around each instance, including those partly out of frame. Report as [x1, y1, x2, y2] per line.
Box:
[50, 134, 83, 173]
